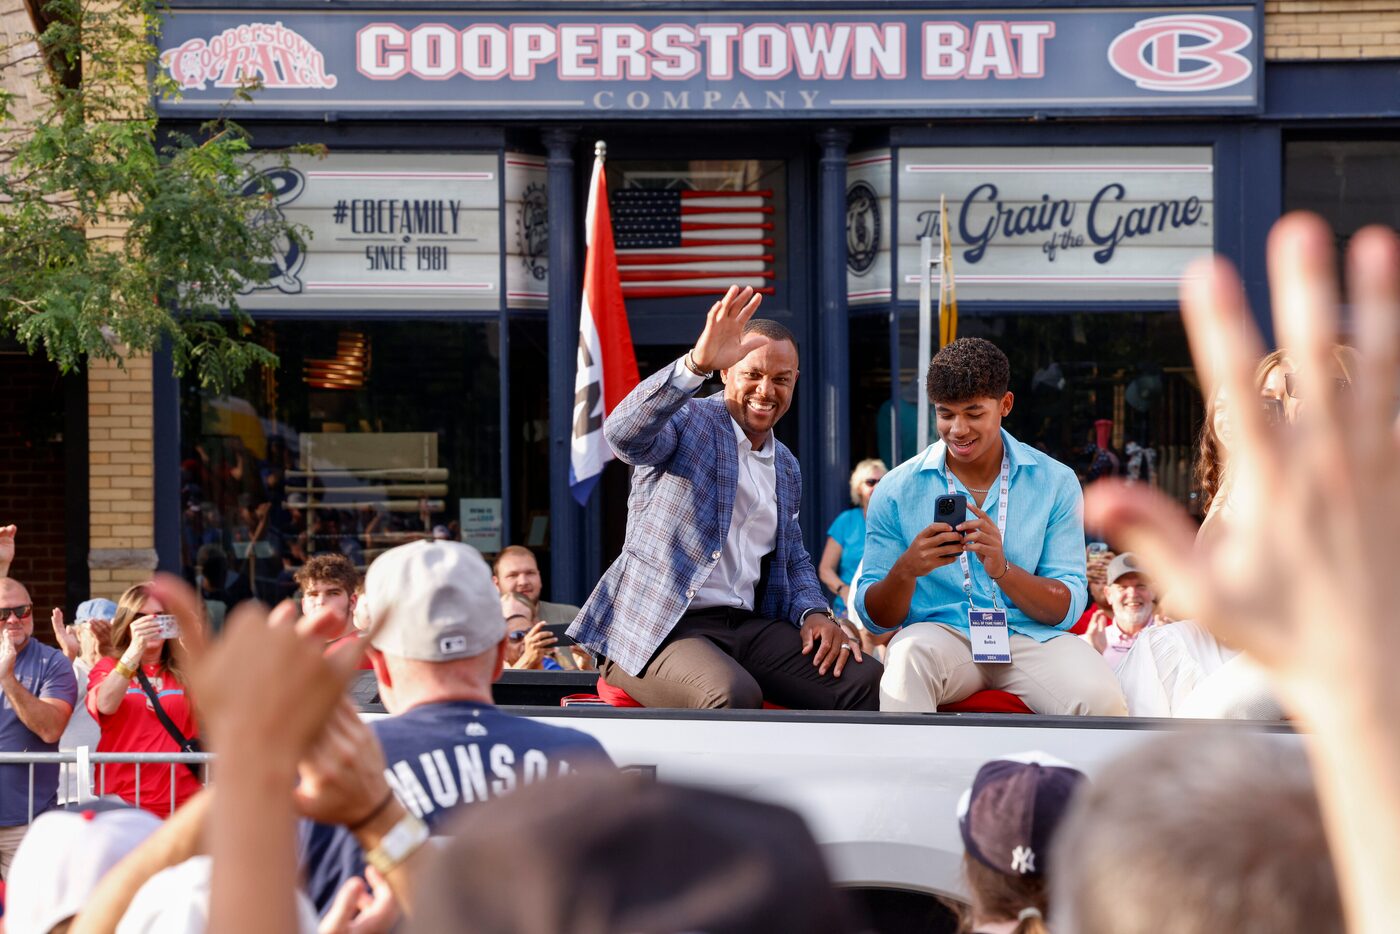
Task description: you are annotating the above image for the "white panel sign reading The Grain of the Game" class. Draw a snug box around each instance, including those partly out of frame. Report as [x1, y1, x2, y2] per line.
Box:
[899, 146, 1215, 301]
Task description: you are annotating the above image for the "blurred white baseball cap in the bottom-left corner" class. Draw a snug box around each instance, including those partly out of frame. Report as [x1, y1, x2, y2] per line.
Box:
[4, 808, 161, 934]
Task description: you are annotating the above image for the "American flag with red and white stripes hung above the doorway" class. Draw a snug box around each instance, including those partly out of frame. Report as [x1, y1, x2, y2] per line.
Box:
[612, 188, 774, 298]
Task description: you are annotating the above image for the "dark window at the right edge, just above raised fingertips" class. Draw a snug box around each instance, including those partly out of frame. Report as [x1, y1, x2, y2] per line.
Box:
[1284, 140, 1400, 242]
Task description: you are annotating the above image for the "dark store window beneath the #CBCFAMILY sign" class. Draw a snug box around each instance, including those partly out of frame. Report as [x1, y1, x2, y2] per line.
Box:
[179, 319, 501, 604]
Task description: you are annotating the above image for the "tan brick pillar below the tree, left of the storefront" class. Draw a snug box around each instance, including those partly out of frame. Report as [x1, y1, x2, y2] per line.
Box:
[88, 357, 155, 599]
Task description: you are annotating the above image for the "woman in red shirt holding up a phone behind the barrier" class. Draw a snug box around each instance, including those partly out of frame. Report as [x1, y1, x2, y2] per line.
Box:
[87, 584, 203, 818]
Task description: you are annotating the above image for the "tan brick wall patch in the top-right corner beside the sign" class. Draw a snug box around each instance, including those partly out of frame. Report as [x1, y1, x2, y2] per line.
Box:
[1264, 0, 1400, 62]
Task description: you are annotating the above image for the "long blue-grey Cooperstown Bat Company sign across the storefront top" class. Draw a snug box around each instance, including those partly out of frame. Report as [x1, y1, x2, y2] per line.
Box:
[160, 0, 1261, 119]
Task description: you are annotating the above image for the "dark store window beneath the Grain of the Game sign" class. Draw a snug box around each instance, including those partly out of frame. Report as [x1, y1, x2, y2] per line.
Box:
[882, 316, 1204, 513]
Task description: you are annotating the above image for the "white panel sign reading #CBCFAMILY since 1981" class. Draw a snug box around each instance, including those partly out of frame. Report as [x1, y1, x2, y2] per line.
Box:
[239, 153, 501, 311]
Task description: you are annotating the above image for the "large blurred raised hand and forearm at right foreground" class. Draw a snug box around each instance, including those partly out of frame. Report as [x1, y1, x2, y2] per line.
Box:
[1085, 214, 1400, 934]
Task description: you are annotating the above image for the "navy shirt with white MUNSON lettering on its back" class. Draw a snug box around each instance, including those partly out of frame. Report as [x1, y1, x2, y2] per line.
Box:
[302, 700, 612, 912]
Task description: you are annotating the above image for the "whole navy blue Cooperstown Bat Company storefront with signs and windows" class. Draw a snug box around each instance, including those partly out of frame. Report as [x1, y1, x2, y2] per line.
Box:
[157, 0, 1400, 602]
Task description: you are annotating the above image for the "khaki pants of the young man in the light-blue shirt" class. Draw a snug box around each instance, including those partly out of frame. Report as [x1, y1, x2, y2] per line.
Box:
[879, 623, 1128, 717]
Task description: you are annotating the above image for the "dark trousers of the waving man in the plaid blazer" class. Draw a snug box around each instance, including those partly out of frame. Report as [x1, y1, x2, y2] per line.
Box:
[603, 606, 885, 710]
